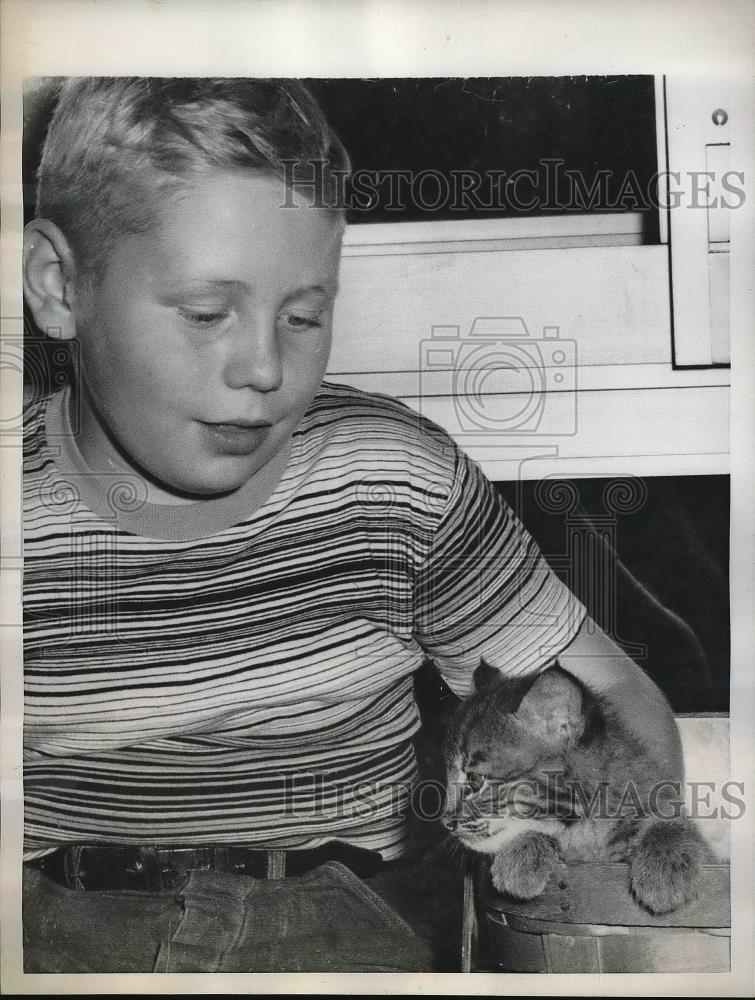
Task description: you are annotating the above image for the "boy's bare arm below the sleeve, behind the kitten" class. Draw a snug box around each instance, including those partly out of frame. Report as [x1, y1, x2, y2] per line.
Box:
[558, 618, 684, 781]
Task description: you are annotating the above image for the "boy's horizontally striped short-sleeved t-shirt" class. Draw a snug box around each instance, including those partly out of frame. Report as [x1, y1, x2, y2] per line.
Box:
[24, 383, 584, 858]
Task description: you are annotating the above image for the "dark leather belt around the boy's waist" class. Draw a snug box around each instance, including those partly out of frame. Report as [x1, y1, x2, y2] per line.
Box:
[27, 841, 384, 892]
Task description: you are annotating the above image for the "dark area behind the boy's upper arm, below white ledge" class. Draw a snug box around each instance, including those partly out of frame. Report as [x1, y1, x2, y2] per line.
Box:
[498, 476, 730, 713]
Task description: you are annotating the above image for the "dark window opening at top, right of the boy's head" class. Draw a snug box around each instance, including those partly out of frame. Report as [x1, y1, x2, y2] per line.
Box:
[306, 76, 657, 230]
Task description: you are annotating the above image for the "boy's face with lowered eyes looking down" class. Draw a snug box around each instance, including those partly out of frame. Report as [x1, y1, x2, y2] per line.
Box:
[71, 173, 341, 499]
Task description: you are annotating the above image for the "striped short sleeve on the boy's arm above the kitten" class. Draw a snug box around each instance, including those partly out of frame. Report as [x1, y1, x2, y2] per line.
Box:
[414, 450, 586, 696]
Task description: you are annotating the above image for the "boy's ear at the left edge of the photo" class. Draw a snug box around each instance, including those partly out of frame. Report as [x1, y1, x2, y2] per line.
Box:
[23, 219, 81, 340]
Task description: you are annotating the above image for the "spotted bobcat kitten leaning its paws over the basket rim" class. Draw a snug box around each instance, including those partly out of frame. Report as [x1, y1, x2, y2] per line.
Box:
[443, 663, 713, 914]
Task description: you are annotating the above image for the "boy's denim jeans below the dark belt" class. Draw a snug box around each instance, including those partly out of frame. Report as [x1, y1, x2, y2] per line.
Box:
[23, 862, 432, 973]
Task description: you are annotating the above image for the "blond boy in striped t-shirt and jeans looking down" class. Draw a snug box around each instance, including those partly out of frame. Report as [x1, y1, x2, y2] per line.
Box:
[24, 78, 681, 972]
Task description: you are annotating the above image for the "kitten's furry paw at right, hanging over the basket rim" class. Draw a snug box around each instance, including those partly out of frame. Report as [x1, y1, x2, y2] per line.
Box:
[630, 820, 711, 914]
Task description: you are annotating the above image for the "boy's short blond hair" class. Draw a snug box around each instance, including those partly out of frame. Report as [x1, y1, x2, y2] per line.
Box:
[36, 77, 349, 277]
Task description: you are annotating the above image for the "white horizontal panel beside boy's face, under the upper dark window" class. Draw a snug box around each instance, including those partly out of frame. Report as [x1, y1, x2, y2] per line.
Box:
[329, 246, 671, 373]
